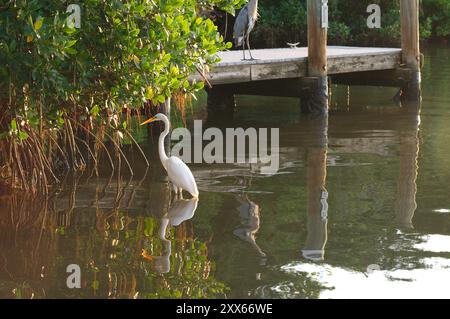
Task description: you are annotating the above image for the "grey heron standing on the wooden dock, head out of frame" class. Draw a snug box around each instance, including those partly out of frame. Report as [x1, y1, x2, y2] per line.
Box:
[233, 0, 258, 60]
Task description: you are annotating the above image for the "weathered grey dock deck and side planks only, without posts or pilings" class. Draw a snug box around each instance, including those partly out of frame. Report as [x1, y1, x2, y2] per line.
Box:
[207, 46, 402, 85]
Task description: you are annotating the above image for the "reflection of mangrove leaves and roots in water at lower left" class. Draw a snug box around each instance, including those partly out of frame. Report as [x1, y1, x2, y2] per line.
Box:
[0, 175, 227, 298]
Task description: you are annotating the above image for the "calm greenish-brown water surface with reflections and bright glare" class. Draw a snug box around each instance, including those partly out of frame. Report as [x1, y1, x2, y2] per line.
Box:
[0, 48, 450, 298]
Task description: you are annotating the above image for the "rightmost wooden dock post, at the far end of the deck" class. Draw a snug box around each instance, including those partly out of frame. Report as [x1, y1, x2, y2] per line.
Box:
[400, 0, 421, 100]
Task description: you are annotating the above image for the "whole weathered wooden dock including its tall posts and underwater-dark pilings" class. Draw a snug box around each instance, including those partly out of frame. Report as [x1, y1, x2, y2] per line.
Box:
[199, 0, 422, 114]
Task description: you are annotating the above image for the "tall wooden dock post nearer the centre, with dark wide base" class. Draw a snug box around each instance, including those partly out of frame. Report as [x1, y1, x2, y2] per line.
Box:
[302, 0, 328, 114]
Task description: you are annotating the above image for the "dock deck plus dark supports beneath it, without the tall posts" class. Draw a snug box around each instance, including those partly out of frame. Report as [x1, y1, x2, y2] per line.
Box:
[202, 46, 413, 112]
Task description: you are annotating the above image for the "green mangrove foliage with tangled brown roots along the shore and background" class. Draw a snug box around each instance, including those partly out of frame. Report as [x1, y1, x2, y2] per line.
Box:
[0, 0, 450, 194]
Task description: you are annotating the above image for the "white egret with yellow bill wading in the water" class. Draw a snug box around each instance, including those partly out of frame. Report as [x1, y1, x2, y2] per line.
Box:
[141, 113, 199, 198]
